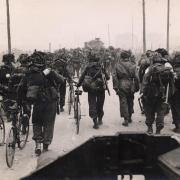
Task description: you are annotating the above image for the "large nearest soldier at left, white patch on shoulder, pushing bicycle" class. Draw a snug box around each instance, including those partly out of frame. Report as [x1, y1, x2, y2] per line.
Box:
[18, 51, 64, 155]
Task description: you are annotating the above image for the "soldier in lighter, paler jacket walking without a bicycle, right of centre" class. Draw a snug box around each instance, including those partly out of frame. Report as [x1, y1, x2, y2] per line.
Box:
[113, 51, 139, 126]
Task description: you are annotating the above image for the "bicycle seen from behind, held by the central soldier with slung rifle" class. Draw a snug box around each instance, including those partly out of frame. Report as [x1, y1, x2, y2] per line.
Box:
[74, 87, 82, 134]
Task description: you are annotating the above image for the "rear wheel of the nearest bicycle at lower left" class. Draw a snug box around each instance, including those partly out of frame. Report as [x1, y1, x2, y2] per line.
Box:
[6, 127, 16, 168]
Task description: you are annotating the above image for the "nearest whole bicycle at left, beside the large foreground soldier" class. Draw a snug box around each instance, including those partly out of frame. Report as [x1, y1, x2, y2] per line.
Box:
[6, 102, 29, 168]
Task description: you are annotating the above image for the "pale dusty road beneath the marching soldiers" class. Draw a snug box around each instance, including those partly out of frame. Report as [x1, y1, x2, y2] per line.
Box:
[0, 82, 178, 180]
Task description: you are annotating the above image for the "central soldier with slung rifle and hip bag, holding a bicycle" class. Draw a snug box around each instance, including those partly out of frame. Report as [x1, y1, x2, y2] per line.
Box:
[77, 53, 109, 129]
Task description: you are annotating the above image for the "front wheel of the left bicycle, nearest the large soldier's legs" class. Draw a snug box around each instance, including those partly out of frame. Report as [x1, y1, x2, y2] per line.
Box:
[18, 117, 29, 149]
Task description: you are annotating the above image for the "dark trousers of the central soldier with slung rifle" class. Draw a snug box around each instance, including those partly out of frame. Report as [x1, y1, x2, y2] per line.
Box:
[88, 90, 105, 119]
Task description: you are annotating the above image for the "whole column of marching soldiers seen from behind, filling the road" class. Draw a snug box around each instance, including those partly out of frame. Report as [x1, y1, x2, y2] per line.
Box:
[0, 47, 180, 155]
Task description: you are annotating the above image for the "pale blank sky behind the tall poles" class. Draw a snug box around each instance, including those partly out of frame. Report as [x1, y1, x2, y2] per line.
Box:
[0, 0, 180, 52]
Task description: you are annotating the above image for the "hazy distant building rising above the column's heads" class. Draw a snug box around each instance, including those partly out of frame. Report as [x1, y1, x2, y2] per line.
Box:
[84, 38, 104, 49]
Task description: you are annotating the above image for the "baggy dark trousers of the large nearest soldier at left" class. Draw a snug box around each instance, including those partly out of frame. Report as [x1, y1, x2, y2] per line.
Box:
[32, 101, 57, 145]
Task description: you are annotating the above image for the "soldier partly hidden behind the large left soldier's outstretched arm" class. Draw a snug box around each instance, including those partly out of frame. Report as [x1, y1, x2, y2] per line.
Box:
[53, 56, 72, 112]
